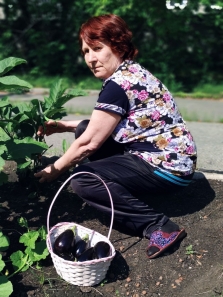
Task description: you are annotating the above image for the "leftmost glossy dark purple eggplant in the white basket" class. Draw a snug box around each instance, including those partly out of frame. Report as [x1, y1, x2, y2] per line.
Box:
[53, 226, 76, 256]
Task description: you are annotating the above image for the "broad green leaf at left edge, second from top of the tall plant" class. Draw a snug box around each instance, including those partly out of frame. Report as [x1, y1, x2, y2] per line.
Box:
[0, 75, 32, 90]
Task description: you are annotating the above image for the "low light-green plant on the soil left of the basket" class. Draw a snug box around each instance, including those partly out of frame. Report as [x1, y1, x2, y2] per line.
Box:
[0, 217, 49, 297]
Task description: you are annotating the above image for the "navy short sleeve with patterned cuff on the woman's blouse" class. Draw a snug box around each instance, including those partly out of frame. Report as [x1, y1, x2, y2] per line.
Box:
[94, 80, 129, 116]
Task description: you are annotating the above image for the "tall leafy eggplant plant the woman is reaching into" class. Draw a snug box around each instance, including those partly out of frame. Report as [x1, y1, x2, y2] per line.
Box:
[0, 57, 85, 185]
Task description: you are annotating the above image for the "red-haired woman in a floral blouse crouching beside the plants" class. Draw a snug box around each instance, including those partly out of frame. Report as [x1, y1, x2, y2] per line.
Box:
[36, 14, 196, 259]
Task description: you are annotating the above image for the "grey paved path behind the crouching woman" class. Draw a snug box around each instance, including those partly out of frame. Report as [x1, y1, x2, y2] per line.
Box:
[6, 90, 223, 180]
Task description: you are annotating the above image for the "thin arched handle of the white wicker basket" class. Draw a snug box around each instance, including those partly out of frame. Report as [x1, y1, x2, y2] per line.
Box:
[47, 171, 114, 240]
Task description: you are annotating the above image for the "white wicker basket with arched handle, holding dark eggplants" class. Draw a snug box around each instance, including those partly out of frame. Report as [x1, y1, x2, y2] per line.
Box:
[46, 171, 115, 286]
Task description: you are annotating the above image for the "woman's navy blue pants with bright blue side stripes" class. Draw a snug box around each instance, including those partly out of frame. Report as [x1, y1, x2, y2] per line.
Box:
[71, 121, 193, 238]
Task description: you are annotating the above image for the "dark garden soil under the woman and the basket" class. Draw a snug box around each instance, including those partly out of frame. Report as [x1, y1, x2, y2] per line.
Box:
[0, 162, 223, 297]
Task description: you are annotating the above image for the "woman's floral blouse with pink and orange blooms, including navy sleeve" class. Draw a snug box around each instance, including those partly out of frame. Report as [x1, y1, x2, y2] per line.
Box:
[95, 60, 197, 175]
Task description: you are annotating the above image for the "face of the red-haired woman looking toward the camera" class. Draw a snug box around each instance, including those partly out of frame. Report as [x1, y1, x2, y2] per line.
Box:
[82, 40, 122, 79]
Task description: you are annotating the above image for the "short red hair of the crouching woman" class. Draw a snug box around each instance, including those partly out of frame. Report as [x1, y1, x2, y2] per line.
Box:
[79, 14, 138, 60]
